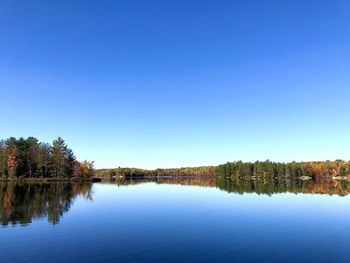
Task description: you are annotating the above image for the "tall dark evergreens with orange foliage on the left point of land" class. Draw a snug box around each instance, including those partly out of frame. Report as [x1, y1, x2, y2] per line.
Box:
[0, 137, 94, 178]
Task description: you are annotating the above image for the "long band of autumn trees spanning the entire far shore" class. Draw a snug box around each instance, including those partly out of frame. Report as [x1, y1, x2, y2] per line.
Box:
[96, 160, 350, 178]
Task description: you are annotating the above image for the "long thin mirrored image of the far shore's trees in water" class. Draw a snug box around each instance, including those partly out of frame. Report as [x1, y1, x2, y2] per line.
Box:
[109, 177, 350, 195]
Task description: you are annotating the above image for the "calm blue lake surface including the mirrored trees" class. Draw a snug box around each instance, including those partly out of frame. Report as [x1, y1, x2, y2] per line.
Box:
[0, 179, 350, 262]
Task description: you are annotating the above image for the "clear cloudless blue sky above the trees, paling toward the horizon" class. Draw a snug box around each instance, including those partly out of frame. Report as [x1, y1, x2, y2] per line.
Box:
[0, 0, 350, 168]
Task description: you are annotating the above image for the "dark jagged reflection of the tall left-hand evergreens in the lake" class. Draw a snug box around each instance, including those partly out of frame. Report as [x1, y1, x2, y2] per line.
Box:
[0, 182, 92, 226]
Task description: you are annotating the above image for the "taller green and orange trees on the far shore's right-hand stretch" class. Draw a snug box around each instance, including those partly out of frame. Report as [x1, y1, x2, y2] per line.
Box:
[215, 160, 350, 178]
